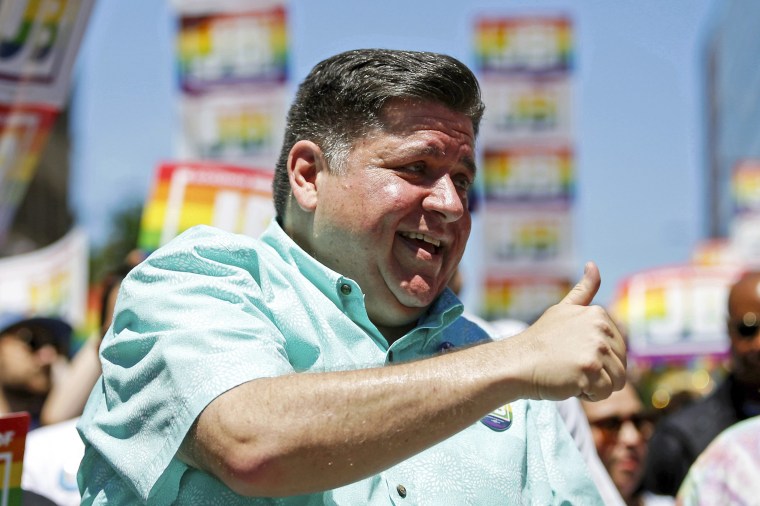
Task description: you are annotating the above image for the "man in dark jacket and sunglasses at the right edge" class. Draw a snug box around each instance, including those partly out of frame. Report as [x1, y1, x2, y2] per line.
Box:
[645, 272, 760, 496]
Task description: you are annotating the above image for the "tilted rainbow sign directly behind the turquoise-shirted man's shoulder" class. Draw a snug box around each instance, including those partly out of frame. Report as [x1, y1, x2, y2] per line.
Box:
[138, 162, 274, 251]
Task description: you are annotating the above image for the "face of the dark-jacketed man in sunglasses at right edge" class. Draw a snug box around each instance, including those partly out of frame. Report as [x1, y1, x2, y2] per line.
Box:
[728, 276, 760, 387]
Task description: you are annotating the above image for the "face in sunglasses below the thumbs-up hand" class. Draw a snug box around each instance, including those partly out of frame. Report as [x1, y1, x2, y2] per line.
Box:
[583, 384, 652, 499]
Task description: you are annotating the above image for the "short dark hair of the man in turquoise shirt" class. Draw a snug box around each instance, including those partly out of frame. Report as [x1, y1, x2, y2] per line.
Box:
[273, 49, 484, 223]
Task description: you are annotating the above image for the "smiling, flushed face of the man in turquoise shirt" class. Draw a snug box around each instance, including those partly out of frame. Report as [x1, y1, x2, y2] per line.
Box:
[309, 102, 475, 330]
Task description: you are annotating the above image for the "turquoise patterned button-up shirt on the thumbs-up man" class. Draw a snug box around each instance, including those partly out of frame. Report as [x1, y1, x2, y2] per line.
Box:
[78, 222, 601, 506]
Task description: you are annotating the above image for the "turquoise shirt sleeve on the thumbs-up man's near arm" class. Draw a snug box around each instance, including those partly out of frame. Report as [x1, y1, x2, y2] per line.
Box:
[85, 229, 292, 501]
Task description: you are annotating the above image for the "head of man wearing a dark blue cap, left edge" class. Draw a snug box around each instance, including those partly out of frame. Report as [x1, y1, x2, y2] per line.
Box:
[0, 314, 71, 428]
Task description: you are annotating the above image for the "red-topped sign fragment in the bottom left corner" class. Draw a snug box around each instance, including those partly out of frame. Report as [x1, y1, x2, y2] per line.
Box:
[0, 412, 30, 506]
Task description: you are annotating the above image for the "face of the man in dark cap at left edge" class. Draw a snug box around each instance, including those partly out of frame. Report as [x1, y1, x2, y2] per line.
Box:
[0, 328, 58, 395]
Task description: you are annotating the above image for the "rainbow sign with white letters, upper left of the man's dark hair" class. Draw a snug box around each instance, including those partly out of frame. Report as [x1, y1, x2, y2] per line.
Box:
[177, 6, 288, 92]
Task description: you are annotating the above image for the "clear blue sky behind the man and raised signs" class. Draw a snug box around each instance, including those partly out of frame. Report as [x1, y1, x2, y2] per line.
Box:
[70, 0, 717, 304]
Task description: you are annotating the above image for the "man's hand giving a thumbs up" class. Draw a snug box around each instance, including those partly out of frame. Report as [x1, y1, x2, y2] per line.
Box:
[507, 262, 626, 401]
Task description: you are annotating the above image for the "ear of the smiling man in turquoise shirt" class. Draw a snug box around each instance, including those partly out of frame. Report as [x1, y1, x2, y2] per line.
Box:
[288, 140, 327, 212]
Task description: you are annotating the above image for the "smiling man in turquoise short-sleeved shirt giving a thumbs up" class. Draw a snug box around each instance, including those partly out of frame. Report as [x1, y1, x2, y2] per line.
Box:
[80, 50, 625, 504]
